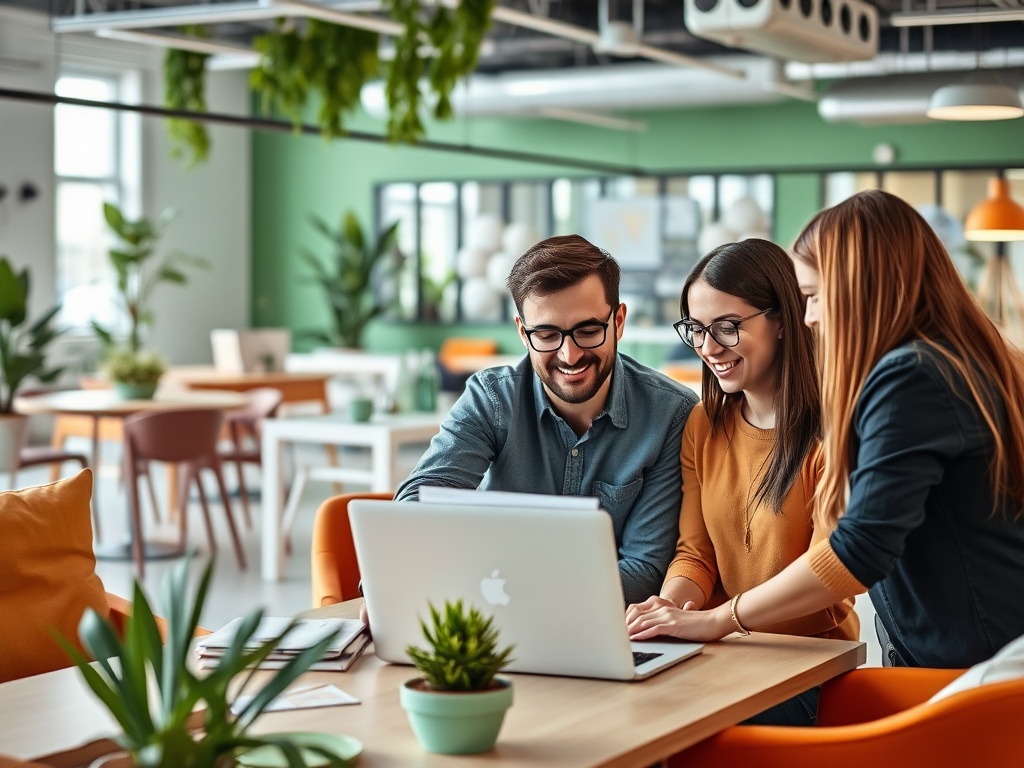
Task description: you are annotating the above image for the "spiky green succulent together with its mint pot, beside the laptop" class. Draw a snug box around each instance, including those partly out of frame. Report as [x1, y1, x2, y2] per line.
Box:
[399, 600, 512, 755]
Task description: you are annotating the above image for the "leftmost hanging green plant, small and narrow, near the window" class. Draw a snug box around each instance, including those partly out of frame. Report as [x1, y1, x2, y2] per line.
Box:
[164, 25, 210, 168]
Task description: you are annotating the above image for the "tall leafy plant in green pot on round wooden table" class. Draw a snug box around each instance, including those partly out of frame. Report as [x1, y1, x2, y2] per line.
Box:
[92, 203, 208, 399]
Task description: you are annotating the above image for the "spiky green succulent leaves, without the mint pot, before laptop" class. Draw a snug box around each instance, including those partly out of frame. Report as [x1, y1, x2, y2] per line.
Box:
[406, 600, 513, 691]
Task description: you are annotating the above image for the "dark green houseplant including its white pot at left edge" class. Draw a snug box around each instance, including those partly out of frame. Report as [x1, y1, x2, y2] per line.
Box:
[0, 256, 61, 472]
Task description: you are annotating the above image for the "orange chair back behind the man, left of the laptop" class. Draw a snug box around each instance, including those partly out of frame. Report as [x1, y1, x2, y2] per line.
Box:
[312, 494, 394, 608]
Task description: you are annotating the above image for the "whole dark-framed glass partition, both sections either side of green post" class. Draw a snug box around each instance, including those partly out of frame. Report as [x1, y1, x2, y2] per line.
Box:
[377, 167, 1024, 331]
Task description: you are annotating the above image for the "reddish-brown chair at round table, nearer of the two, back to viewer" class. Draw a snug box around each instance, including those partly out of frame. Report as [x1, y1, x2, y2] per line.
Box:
[124, 410, 246, 577]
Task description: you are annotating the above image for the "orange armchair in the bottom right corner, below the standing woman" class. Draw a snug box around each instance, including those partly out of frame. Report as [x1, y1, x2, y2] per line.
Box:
[669, 668, 1024, 768]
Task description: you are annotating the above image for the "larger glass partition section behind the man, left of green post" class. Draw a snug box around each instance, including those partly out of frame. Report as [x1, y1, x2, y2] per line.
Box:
[377, 173, 774, 327]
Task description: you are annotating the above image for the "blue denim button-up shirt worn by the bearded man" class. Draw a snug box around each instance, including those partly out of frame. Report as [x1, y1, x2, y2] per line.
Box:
[395, 354, 697, 603]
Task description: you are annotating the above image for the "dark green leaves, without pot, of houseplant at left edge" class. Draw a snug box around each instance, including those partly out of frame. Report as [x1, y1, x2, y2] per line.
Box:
[0, 256, 61, 414]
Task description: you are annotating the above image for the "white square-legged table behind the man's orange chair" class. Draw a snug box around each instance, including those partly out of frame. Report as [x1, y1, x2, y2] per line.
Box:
[261, 413, 444, 582]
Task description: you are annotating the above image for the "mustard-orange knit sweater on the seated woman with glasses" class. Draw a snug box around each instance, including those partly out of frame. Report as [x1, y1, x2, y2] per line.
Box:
[666, 403, 860, 640]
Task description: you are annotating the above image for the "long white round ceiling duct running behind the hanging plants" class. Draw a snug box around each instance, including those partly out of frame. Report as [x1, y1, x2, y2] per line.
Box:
[361, 56, 782, 118]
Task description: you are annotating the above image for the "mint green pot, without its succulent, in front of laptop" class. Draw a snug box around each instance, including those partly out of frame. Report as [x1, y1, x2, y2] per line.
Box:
[398, 677, 512, 755]
